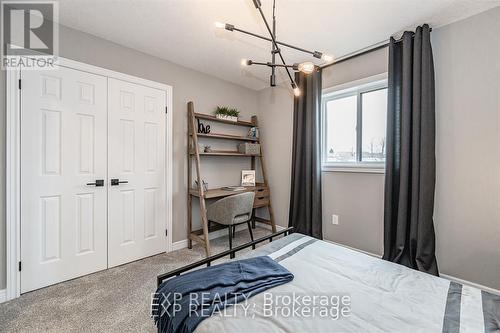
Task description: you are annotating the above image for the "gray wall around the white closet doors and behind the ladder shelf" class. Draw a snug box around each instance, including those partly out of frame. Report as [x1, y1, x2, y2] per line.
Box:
[0, 27, 259, 289]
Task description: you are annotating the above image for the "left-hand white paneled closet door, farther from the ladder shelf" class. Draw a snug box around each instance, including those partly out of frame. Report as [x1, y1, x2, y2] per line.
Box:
[21, 67, 107, 292]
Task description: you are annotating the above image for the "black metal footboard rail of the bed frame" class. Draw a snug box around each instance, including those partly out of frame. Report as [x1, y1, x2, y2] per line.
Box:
[156, 227, 293, 287]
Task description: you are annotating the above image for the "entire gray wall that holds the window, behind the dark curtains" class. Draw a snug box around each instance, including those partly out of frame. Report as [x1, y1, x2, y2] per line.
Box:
[260, 8, 500, 289]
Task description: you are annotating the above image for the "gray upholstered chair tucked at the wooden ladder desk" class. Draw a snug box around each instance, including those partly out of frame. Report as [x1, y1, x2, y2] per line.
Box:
[207, 192, 255, 257]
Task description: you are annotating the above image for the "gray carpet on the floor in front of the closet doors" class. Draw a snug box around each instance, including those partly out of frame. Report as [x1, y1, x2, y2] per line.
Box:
[0, 228, 270, 332]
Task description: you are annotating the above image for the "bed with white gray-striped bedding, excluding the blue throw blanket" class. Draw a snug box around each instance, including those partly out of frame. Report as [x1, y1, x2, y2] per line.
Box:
[158, 228, 500, 333]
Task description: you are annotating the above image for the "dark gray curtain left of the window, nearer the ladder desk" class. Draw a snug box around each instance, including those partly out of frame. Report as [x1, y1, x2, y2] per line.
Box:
[288, 70, 323, 239]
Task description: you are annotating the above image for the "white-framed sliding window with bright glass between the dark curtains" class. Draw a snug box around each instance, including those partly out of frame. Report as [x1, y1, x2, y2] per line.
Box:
[323, 78, 387, 170]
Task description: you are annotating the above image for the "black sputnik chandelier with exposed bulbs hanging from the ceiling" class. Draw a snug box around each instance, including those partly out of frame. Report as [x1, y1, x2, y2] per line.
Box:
[215, 0, 333, 96]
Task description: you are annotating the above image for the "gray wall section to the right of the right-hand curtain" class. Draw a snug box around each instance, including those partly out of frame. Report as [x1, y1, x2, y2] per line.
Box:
[432, 8, 500, 290]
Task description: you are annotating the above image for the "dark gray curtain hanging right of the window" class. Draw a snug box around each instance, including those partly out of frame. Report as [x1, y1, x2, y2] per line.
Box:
[384, 25, 438, 275]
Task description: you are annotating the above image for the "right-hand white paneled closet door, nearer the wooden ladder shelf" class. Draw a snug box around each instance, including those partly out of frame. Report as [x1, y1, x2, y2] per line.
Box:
[108, 78, 167, 267]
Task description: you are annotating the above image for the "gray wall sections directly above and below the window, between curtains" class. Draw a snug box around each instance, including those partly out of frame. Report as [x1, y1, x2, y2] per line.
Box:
[323, 48, 388, 255]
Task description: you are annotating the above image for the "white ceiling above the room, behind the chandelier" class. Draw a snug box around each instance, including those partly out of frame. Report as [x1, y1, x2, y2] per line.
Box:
[59, 0, 500, 89]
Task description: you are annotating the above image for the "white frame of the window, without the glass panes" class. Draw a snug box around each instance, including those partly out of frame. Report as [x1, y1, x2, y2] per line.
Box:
[321, 73, 387, 173]
